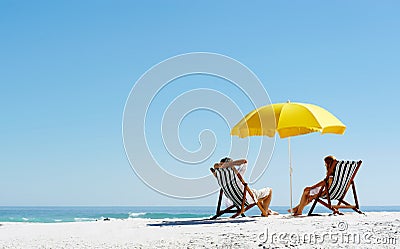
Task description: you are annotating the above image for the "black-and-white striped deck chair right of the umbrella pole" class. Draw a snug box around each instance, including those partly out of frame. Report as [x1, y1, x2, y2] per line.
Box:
[308, 160, 362, 215]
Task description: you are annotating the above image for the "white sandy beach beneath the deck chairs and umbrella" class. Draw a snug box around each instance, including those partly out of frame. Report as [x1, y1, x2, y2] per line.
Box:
[0, 212, 400, 248]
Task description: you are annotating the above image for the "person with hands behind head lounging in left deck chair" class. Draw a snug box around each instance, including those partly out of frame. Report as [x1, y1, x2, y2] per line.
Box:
[214, 157, 278, 216]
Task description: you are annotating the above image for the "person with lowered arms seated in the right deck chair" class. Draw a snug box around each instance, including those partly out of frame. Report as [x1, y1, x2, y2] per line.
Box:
[288, 156, 336, 216]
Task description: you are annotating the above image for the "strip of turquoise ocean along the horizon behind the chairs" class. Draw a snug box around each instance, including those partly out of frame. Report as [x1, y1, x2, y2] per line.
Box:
[0, 205, 400, 223]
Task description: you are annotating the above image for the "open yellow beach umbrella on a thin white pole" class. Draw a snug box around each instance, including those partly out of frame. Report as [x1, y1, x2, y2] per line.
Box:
[231, 101, 346, 212]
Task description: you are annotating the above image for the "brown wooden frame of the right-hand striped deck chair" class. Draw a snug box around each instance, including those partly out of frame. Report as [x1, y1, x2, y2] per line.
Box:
[308, 160, 363, 216]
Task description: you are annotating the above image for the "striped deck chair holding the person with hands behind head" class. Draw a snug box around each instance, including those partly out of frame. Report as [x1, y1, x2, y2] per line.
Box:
[210, 167, 267, 219]
